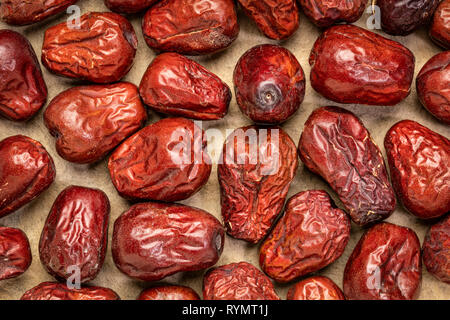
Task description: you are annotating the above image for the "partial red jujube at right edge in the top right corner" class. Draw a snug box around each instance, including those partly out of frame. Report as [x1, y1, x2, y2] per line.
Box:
[429, 0, 450, 50]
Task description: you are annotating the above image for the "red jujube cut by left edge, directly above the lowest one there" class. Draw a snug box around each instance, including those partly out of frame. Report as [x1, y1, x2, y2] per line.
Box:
[0, 135, 56, 218]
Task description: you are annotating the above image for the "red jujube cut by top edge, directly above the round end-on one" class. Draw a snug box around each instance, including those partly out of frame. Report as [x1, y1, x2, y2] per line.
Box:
[238, 0, 299, 40]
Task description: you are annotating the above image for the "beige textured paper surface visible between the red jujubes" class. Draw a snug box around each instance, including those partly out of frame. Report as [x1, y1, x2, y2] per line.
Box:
[0, 0, 450, 299]
